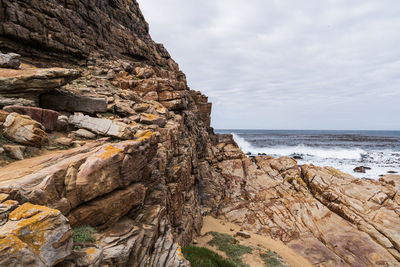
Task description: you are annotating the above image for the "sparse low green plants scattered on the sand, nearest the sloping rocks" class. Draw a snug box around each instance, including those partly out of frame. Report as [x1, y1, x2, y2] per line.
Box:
[207, 232, 252, 267]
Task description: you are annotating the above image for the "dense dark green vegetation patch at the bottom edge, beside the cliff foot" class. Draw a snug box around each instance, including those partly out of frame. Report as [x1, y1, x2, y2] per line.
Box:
[182, 245, 236, 267]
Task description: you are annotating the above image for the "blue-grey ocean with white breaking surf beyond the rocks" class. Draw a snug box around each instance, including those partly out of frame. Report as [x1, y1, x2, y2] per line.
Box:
[216, 130, 400, 179]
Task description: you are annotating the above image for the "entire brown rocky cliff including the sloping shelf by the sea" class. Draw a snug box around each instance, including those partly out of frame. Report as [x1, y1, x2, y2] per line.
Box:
[0, 0, 400, 266]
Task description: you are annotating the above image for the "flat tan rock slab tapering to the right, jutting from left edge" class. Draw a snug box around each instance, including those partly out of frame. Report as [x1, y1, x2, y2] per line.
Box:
[0, 68, 80, 98]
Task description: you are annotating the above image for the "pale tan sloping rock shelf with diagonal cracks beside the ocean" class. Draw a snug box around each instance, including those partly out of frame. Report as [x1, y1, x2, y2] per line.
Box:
[202, 138, 400, 266]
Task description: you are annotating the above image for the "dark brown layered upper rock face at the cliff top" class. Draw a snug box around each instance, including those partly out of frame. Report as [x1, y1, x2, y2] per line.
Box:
[0, 0, 172, 65]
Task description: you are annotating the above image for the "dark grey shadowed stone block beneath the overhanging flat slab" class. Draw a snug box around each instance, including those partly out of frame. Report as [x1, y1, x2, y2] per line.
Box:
[40, 91, 107, 114]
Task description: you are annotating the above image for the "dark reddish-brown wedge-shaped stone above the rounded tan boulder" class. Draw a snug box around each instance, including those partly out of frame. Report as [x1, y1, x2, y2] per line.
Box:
[4, 106, 59, 131]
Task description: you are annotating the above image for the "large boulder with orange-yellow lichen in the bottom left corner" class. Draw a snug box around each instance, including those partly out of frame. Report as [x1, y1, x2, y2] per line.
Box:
[0, 203, 73, 266]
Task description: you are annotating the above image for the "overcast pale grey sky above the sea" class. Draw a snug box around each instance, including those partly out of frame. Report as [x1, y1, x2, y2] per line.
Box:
[138, 0, 400, 130]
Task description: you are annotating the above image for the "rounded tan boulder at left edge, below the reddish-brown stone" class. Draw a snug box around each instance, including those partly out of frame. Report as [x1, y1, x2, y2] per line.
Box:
[0, 111, 48, 147]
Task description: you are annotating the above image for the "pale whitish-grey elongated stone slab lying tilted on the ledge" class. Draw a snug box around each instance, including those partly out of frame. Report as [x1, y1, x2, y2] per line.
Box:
[69, 113, 132, 139]
